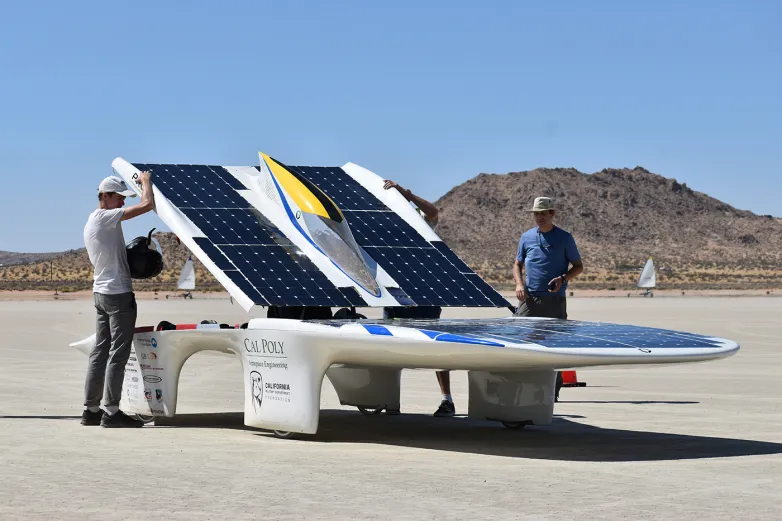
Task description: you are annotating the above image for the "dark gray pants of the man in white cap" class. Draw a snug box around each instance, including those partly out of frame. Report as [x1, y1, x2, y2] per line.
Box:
[84, 292, 136, 407]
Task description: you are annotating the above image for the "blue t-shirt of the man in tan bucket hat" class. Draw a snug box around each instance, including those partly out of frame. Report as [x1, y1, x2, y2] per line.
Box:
[516, 226, 581, 297]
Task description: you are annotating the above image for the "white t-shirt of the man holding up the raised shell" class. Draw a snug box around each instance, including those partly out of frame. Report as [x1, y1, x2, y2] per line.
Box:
[84, 208, 133, 295]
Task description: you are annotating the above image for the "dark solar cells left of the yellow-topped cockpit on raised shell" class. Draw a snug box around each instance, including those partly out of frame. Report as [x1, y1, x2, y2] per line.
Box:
[133, 163, 367, 306]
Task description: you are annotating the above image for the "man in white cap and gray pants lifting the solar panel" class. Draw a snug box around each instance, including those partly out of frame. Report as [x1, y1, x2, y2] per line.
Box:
[81, 172, 155, 427]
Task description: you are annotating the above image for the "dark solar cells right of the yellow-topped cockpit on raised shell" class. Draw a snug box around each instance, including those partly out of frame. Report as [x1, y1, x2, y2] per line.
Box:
[280, 163, 508, 307]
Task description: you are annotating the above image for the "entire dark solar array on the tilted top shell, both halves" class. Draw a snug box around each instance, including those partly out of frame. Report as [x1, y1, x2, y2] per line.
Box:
[134, 158, 507, 307]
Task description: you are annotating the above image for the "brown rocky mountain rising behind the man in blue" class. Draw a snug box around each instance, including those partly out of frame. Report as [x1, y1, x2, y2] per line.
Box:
[436, 167, 782, 288]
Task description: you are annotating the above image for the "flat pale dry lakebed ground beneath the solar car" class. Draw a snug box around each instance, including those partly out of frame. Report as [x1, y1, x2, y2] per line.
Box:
[0, 293, 782, 520]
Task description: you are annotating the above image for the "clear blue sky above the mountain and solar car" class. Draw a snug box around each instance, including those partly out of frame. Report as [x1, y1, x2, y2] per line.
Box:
[0, 1, 782, 252]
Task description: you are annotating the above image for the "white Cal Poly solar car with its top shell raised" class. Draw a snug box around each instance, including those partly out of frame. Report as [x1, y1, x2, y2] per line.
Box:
[72, 153, 739, 436]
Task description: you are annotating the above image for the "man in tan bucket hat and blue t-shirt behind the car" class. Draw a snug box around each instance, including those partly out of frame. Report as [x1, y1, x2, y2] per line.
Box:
[513, 197, 584, 395]
